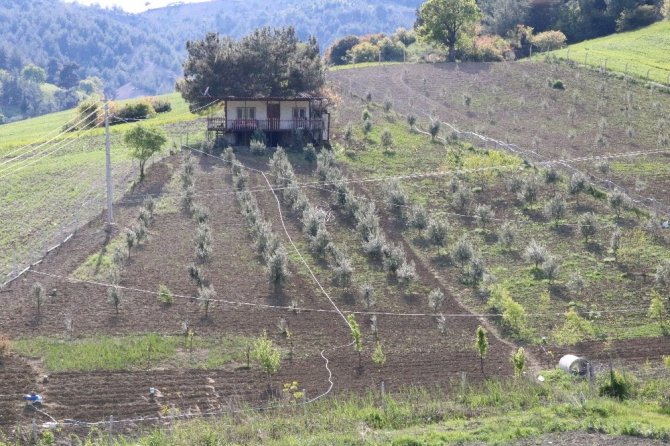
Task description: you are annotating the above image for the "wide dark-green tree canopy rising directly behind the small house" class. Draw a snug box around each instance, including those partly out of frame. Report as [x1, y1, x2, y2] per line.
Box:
[177, 27, 325, 107]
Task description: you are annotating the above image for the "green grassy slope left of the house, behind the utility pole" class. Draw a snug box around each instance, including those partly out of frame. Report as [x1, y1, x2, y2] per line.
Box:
[0, 93, 209, 282]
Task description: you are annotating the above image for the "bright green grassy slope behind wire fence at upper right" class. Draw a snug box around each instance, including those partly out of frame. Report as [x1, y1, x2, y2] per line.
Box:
[550, 20, 670, 84]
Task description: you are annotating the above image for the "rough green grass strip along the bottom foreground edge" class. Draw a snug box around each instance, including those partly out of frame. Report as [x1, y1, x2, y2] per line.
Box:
[22, 371, 670, 446]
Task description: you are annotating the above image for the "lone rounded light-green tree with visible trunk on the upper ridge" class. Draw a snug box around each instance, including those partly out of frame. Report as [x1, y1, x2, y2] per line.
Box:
[414, 0, 482, 61]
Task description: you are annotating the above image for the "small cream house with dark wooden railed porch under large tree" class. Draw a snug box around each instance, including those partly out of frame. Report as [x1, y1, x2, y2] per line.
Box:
[207, 94, 330, 146]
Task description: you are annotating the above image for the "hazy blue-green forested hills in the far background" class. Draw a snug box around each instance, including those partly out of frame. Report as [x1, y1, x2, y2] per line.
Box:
[0, 0, 420, 123]
